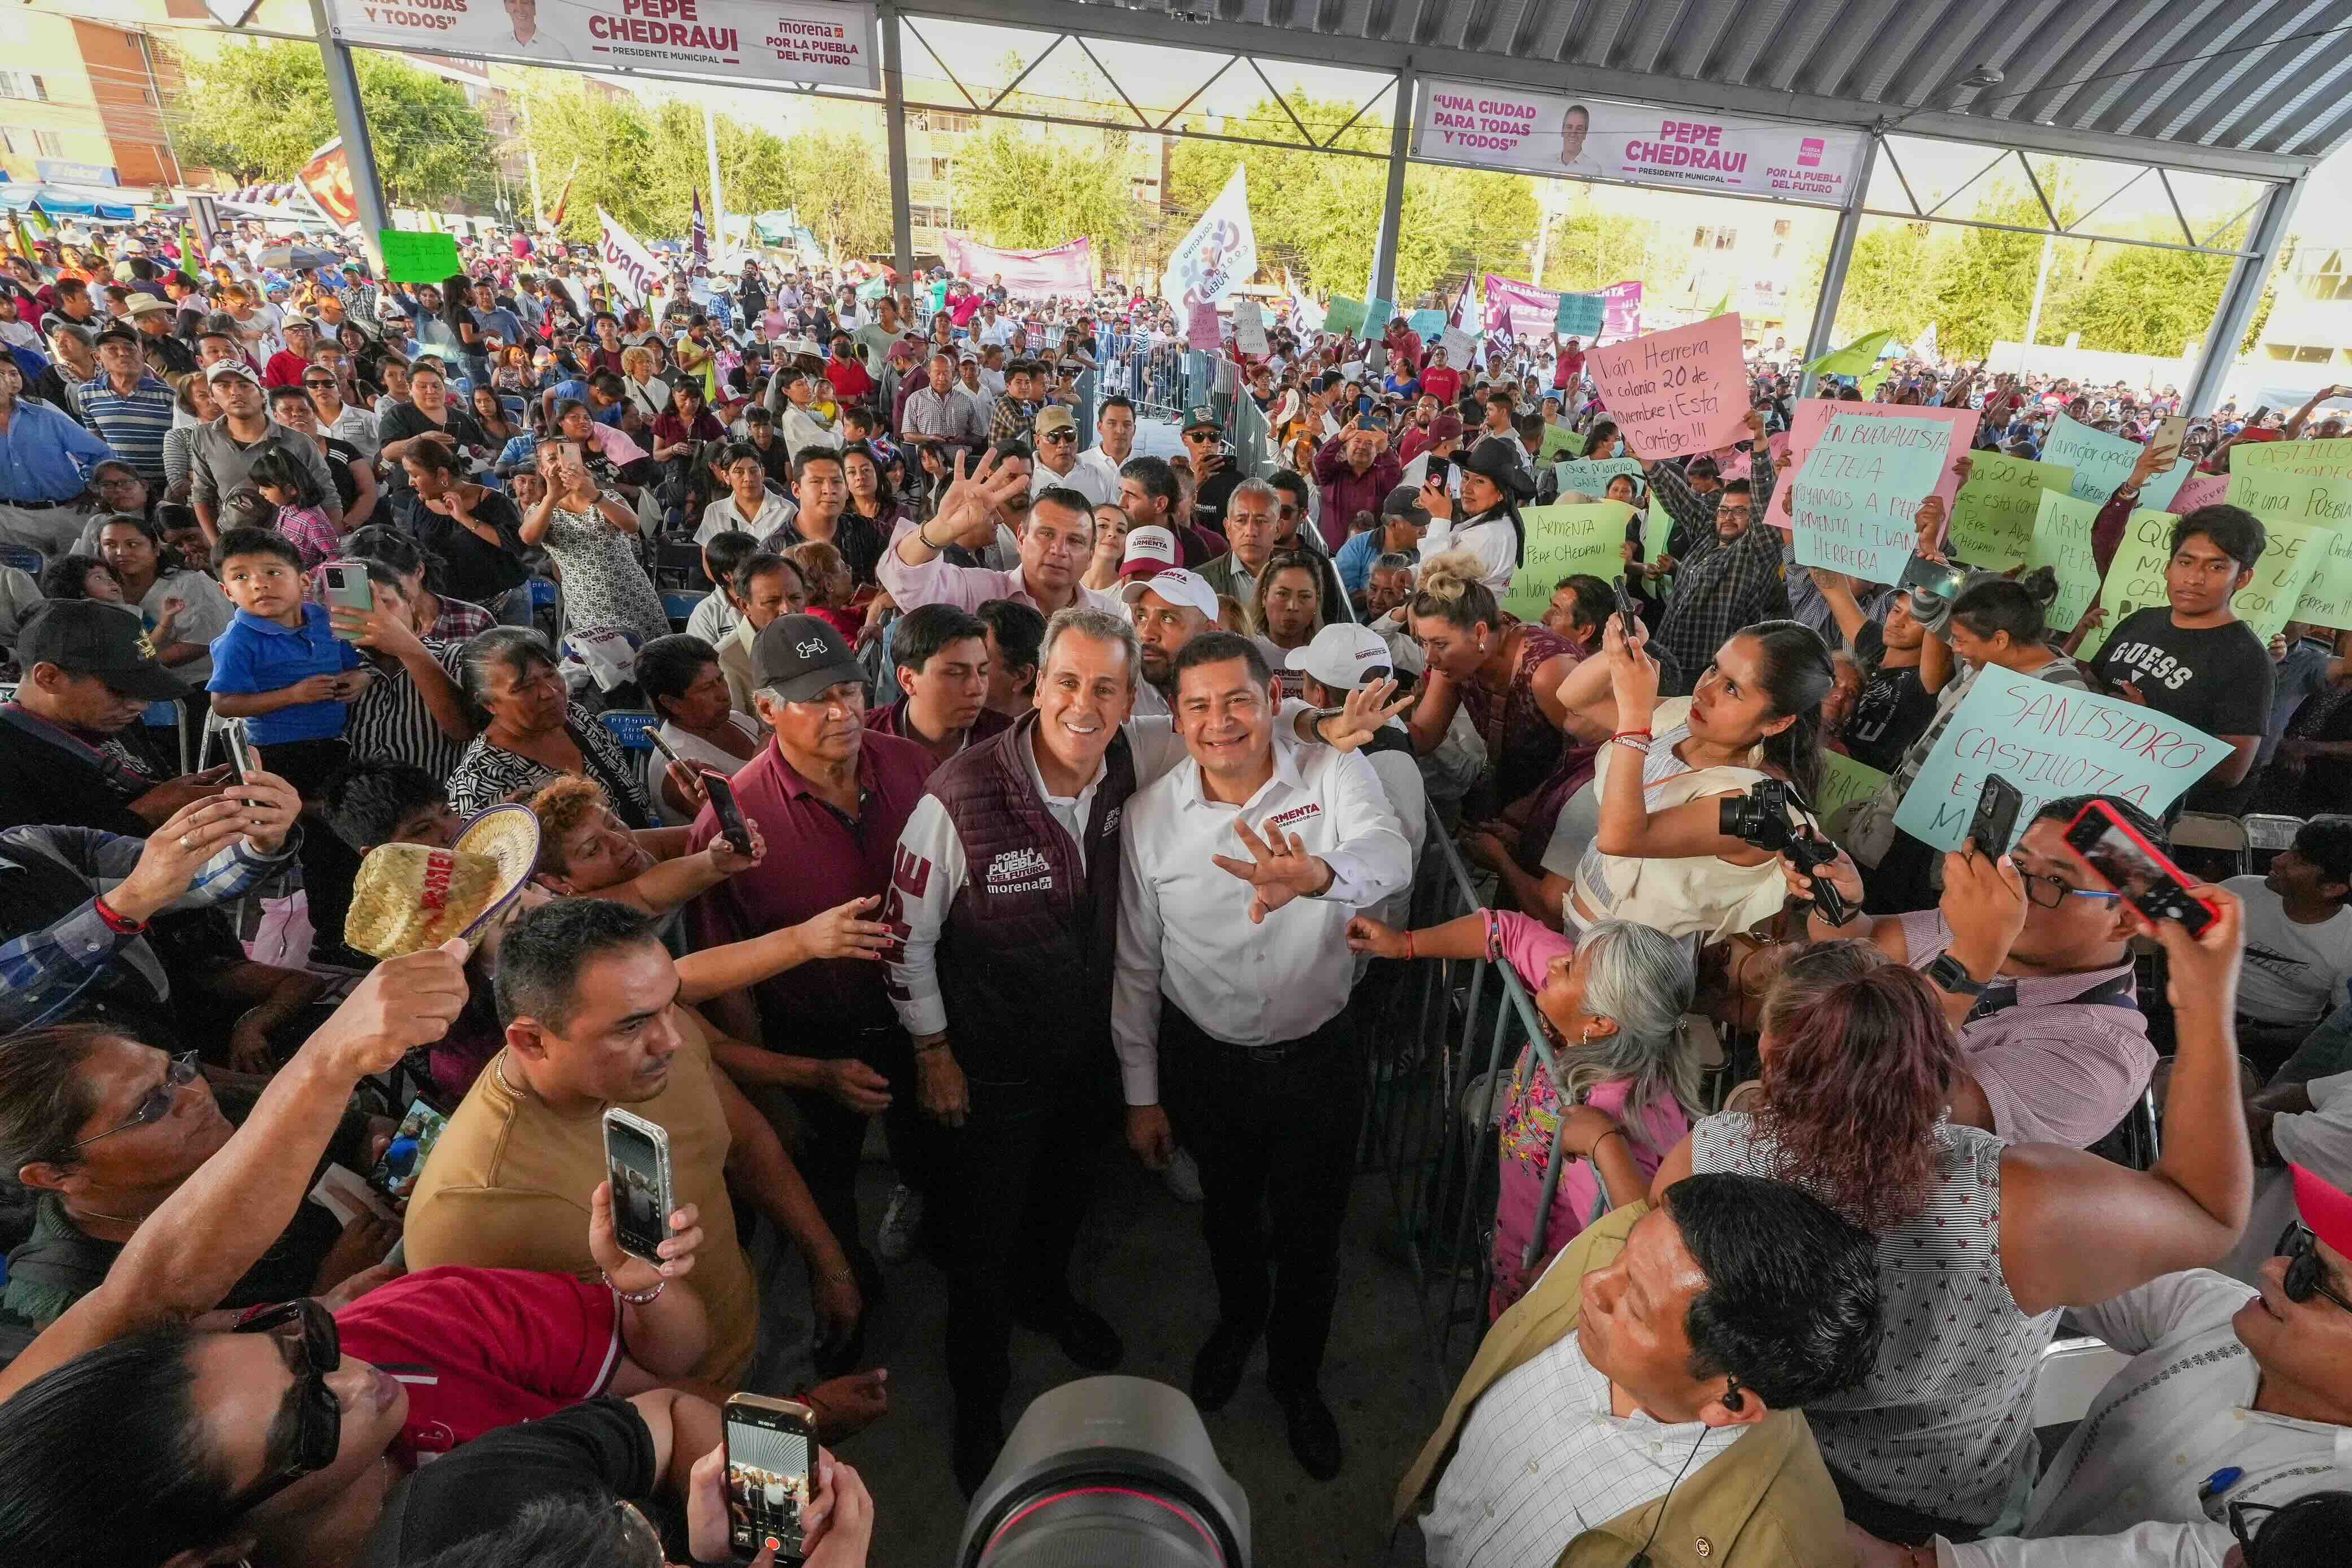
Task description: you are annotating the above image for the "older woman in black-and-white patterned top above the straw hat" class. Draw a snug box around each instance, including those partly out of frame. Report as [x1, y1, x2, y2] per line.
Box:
[449, 625, 654, 828]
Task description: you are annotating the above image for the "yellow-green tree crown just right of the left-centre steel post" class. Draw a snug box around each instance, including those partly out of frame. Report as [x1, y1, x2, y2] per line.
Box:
[955, 120, 1141, 252]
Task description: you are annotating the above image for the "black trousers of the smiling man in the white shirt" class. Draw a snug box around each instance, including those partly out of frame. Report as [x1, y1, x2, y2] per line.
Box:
[1160, 1002, 1364, 1389]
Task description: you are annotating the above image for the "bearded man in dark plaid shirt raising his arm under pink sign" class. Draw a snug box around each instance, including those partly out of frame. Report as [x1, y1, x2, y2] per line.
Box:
[1642, 414, 1788, 696]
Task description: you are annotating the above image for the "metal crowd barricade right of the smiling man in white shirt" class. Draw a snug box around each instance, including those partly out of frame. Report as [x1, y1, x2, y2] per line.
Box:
[1359, 811, 1599, 1387]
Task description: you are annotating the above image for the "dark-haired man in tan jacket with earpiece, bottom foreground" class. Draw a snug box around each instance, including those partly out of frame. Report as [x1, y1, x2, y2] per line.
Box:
[1395, 1175, 1879, 1568]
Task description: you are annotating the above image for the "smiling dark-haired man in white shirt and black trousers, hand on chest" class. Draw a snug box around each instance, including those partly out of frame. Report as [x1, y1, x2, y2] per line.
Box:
[1113, 633, 1411, 1481]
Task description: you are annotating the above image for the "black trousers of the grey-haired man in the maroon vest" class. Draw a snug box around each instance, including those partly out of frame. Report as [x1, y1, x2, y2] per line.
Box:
[936, 1053, 1119, 1418]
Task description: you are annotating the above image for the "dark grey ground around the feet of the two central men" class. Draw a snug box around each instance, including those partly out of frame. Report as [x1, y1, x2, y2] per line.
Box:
[842, 1159, 1451, 1568]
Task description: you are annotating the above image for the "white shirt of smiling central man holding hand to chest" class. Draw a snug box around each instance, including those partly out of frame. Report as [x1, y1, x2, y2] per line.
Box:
[1110, 738, 1413, 1105]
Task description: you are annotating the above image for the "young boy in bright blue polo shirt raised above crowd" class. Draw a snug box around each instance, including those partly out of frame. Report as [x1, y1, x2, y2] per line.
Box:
[205, 527, 371, 968]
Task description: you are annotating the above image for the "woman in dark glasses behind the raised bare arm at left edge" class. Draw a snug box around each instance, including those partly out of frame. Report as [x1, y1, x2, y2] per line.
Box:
[0, 1023, 400, 1328]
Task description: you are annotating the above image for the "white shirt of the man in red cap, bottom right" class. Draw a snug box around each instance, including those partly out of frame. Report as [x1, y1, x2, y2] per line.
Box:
[1936, 1270, 2352, 1568]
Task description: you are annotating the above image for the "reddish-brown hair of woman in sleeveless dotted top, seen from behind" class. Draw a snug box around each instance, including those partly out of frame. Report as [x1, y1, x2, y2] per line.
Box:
[1757, 941, 1959, 1232]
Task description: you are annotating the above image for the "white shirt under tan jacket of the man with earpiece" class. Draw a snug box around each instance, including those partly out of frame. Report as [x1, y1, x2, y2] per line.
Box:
[1421, 1258, 1745, 1568]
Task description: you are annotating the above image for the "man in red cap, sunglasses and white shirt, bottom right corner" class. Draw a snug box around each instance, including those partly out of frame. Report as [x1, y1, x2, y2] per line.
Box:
[1863, 1166, 2352, 1568]
